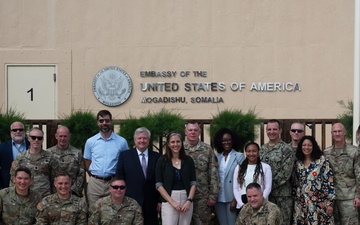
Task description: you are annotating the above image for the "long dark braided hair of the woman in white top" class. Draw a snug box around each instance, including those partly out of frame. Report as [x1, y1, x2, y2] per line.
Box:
[237, 142, 265, 188]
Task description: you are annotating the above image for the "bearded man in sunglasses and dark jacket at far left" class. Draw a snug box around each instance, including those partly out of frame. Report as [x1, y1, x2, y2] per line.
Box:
[0, 121, 30, 189]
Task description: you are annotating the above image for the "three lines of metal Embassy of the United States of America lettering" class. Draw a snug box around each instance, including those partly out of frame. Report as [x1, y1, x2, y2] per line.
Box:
[140, 71, 301, 104]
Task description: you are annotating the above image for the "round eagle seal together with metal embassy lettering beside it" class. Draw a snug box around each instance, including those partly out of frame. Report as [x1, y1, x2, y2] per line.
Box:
[93, 66, 301, 106]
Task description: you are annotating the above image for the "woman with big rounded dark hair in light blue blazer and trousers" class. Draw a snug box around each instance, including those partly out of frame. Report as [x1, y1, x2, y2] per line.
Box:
[213, 128, 245, 225]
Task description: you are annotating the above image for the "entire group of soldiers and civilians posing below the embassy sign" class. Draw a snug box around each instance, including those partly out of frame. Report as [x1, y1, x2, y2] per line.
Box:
[0, 110, 360, 225]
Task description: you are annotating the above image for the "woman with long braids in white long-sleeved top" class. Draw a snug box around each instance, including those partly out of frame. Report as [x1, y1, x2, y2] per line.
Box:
[233, 142, 272, 209]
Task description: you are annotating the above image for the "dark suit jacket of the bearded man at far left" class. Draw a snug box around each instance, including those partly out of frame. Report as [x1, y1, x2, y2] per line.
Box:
[0, 138, 30, 189]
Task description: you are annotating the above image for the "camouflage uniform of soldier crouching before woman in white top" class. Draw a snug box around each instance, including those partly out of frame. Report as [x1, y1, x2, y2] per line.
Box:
[236, 199, 283, 225]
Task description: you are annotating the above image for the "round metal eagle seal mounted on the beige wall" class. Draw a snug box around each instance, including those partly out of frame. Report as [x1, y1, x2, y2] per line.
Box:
[93, 66, 133, 106]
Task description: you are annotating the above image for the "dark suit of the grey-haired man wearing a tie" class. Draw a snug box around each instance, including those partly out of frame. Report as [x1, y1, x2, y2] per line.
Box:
[116, 148, 160, 225]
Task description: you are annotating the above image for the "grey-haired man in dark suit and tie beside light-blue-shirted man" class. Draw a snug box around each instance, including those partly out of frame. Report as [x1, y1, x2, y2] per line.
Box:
[116, 127, 161, 225]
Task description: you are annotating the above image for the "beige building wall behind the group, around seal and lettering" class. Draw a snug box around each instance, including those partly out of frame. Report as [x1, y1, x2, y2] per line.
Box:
[0, 0, 354, 119]
